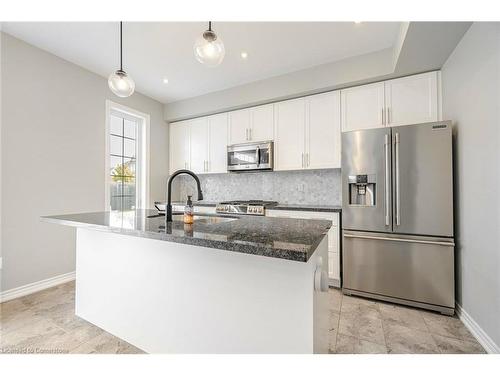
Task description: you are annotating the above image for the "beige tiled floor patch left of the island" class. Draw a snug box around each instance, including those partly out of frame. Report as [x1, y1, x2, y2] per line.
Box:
[0, 282, 142, 354]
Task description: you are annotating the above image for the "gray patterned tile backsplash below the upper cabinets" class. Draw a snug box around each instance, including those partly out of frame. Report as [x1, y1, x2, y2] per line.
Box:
[174, 169, 341, 205]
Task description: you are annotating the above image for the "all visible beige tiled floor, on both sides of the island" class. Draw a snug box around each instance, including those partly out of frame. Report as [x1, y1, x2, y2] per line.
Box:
[0, 283, 484, 354]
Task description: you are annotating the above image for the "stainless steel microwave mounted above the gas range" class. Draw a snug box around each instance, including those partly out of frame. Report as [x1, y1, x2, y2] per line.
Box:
[227, 141, 273, 172]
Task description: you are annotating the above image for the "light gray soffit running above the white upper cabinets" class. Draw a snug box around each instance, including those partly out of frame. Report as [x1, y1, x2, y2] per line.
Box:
[165, 22, 471, 122]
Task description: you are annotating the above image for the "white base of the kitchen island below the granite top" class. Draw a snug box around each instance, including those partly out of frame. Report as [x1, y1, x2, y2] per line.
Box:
[76, 227, 328, 353]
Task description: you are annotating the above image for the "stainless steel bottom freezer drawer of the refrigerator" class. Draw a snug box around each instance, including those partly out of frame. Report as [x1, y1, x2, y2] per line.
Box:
[343, 231, 455, 308]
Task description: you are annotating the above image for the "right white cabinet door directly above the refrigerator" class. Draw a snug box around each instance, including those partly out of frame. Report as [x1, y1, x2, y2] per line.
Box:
[385, 72, 438, 126]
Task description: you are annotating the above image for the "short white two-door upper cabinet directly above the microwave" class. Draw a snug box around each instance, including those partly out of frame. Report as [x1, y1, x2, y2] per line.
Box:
[229, 104, 274, 144]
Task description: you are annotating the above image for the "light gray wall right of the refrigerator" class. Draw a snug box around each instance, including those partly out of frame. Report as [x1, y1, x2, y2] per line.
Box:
[442, 23, 500, 346]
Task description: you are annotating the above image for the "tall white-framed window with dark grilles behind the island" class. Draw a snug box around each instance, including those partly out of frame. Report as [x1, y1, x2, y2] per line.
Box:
[106, 102, 149, 211]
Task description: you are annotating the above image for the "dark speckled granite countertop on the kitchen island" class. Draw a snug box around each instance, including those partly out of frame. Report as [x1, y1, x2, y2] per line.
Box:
[42, 210, 331, 262]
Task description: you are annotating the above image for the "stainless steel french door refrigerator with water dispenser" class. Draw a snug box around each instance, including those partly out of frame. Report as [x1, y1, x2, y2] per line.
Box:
[342, 121, 455, 315]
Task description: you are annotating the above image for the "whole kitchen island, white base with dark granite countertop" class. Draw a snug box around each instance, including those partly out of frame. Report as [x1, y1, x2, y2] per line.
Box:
[42, 210, 331, 353]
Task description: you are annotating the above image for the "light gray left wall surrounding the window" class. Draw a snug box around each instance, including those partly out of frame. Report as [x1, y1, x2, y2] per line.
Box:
[1, 33, 168, 290]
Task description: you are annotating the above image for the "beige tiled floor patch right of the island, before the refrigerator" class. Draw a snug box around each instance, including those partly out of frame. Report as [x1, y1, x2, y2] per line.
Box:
[329, 289, 484, 354]
